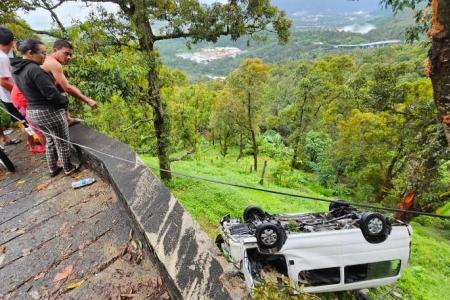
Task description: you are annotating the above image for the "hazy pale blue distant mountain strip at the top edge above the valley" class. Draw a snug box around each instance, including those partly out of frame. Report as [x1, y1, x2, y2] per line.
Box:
[272, 0, 381, 14]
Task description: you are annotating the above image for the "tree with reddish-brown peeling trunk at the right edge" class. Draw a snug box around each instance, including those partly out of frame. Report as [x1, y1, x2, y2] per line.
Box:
[381, 0, 450, 147]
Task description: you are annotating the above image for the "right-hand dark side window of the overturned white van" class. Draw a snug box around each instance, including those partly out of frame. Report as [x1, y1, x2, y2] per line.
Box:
[344, 259, 401, 283]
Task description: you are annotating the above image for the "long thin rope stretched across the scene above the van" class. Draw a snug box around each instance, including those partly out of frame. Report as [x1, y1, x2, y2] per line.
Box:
[0, 106, 450, 219]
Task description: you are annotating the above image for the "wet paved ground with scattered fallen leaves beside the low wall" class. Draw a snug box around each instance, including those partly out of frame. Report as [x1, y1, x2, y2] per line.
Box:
[0, 134, 169, 299]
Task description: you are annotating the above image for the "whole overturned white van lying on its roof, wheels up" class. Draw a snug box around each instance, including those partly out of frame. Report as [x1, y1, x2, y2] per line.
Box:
[216, 201, 412, 293]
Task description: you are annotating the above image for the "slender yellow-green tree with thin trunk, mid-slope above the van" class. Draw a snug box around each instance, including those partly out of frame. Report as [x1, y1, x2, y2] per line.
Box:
[228, 58, 269, 171]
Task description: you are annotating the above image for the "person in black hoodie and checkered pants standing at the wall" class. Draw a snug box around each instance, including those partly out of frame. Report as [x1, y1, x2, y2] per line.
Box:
[12, 39, 79, 177]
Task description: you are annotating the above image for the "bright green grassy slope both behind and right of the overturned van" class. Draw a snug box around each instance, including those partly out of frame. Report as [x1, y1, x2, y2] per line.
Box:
[139, 145, 450, 299]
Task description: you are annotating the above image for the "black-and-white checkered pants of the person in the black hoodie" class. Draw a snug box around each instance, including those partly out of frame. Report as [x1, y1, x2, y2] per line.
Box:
[27, 109, 72, 173]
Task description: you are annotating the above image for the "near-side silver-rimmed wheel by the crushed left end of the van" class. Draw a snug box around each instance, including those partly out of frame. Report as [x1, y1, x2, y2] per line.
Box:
[255, 223, 286, 252]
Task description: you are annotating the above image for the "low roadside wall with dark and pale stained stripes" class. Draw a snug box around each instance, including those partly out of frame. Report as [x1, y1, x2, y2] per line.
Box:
[70, 124, 243, 300]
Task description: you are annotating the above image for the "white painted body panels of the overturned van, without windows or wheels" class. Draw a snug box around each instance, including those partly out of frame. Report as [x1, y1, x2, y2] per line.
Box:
[225, 224, 412, 293]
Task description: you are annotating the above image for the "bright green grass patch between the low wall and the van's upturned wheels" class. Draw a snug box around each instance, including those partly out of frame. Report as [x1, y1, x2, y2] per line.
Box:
[142, 146, 328, 237]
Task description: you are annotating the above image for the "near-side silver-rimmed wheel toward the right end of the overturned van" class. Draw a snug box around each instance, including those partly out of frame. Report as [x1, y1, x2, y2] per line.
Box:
[359, 212, 391, 244]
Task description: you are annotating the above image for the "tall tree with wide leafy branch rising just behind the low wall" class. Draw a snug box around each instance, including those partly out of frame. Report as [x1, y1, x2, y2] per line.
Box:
[10, 0, 291, 180]
